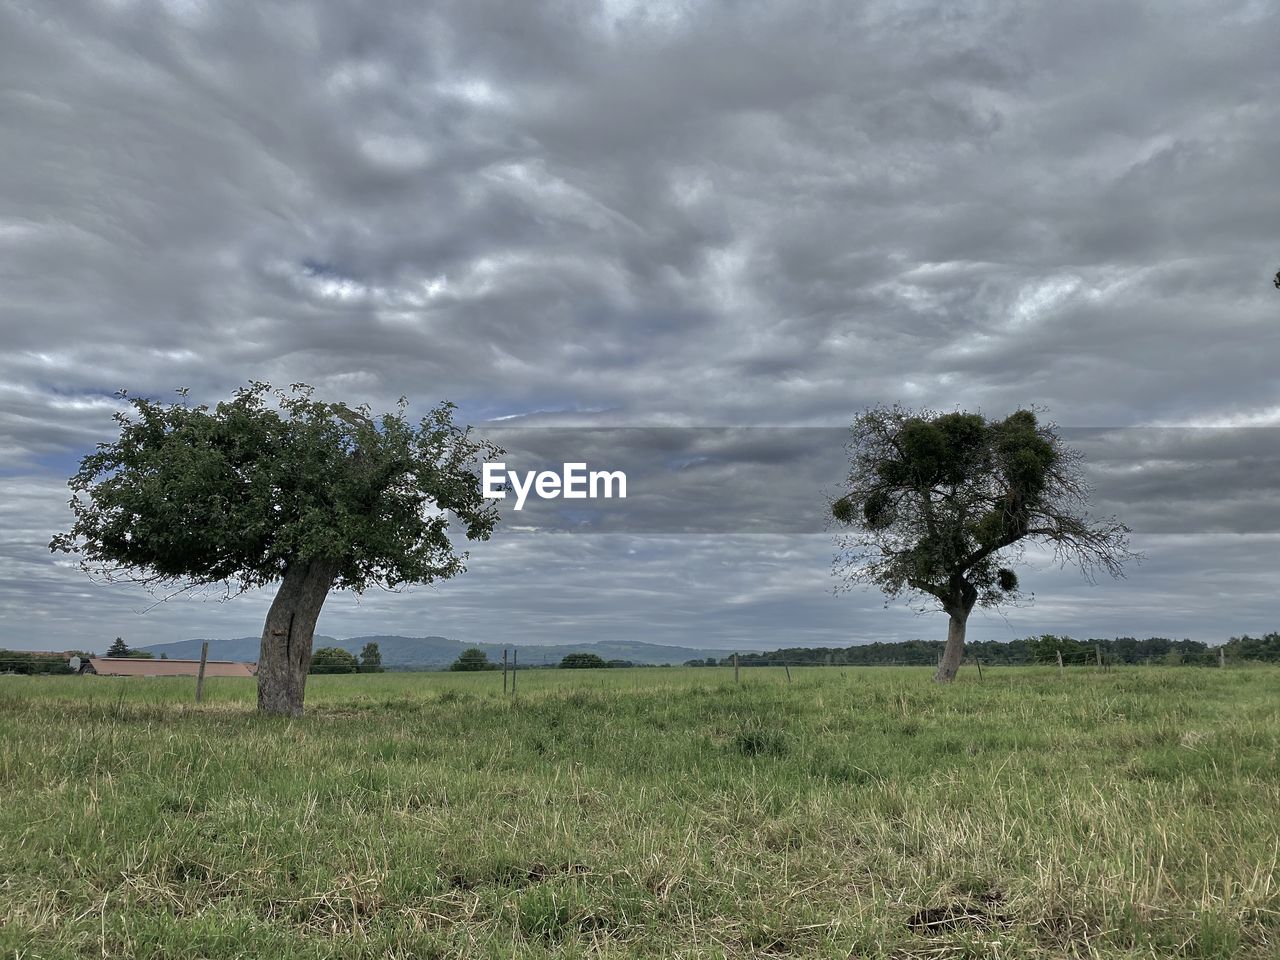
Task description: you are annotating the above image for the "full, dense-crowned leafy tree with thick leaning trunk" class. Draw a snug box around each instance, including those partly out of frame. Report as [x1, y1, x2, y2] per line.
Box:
[50, 383, 500, 716]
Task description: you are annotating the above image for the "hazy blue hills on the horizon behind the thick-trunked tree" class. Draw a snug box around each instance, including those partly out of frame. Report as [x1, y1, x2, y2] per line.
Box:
[141, 635, 726, 668]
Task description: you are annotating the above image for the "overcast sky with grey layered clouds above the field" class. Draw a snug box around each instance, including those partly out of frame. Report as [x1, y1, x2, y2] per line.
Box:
[0, 0, 1280, 649]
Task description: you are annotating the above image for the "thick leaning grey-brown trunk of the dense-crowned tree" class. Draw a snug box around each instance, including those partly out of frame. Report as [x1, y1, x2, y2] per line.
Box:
[257, 559, 338, 717]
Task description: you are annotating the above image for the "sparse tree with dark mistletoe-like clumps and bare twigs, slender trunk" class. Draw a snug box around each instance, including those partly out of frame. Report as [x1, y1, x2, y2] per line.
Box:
[831, 407, 1137, 682]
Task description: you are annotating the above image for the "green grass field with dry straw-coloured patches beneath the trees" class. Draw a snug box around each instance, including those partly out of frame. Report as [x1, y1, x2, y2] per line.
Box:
[0, 667, 1280, 960]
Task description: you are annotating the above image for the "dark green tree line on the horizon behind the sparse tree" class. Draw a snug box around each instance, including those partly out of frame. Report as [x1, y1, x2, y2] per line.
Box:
[685, 632, 1280, 667]
